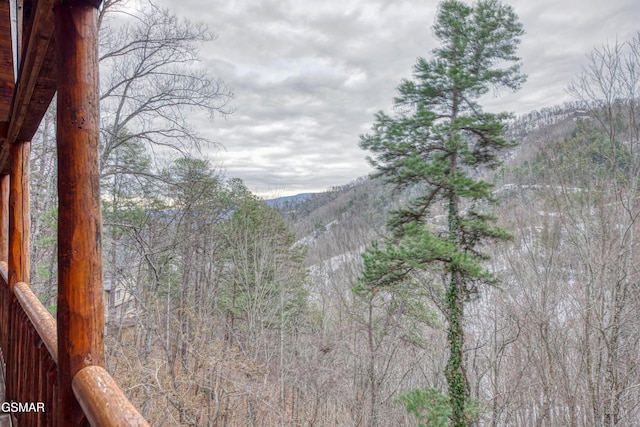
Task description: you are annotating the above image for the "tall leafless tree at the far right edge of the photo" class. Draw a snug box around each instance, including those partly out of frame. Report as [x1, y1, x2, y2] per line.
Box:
[569, 33, 640, 426]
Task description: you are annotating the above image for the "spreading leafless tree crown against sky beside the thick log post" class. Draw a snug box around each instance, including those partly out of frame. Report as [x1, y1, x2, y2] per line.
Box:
[100, 0, 232, 177]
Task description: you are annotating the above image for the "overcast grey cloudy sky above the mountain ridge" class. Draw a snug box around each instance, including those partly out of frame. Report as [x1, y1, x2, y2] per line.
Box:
[151, 0, 640, 197]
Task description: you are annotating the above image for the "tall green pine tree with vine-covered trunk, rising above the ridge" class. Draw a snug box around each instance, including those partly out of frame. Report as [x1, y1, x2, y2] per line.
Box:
[360, 0, 525, 427]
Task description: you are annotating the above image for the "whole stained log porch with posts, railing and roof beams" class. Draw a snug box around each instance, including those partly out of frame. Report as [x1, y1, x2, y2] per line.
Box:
[0, 0, 148, 426]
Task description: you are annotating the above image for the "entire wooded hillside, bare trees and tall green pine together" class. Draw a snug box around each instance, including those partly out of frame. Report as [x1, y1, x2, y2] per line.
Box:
[30, 0, 640, 427]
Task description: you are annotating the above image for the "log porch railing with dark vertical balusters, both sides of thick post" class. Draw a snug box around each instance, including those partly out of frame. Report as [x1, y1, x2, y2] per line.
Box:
[0, 262, 149, 427]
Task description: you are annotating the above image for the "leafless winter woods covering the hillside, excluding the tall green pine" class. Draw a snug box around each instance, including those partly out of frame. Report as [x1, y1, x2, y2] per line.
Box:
[23, 0, 640, 427]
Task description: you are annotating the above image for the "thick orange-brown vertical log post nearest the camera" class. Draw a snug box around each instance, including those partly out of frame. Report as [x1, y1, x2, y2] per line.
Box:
[54, 0, 104, 426]
